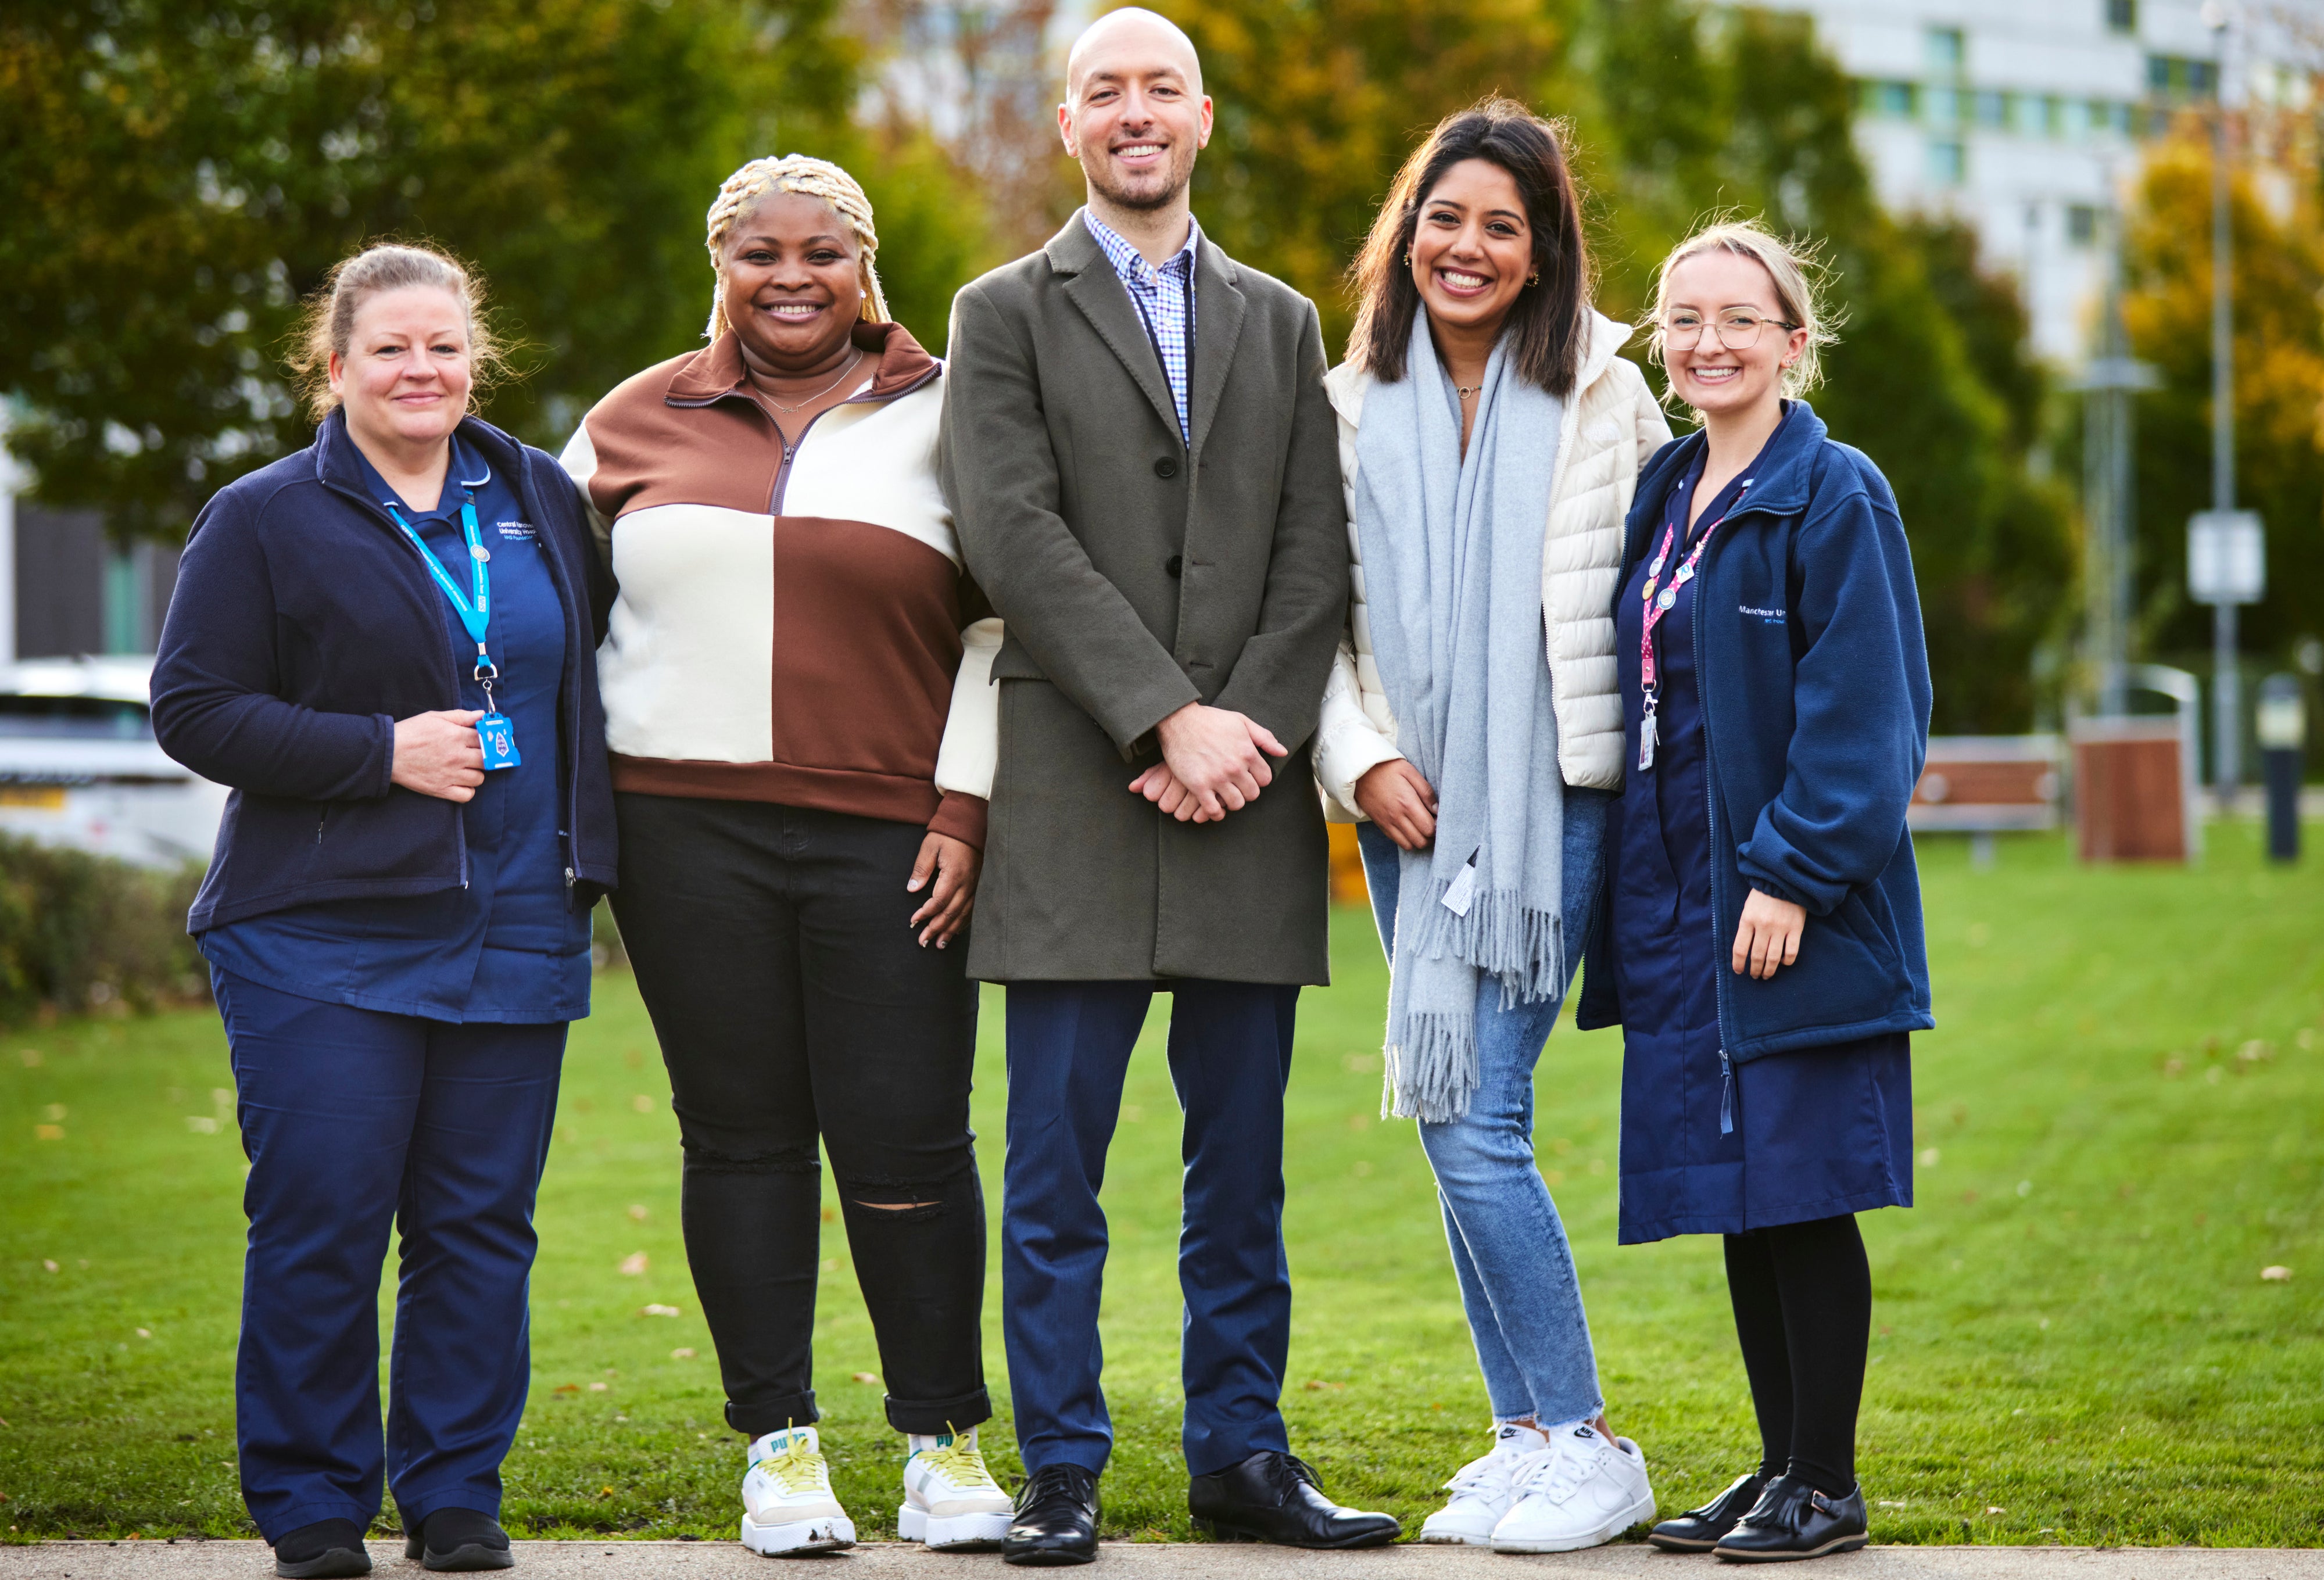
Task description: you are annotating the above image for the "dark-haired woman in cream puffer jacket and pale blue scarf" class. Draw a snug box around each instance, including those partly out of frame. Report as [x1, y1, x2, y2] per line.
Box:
[1315, 100, 1671, 1552]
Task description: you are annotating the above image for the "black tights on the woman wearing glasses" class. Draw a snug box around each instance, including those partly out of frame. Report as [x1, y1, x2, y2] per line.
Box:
[1727, 1213, 1873, 1496]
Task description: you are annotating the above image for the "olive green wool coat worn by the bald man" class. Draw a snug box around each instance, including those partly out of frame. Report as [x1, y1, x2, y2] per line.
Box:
[939, 214, 1348, 983]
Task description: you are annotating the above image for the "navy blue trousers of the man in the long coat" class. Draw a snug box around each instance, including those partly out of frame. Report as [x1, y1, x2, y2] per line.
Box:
[1002, 980, 1299, 1475]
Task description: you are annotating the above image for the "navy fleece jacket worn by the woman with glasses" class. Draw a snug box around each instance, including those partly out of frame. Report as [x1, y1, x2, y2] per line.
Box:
[1575, 402, 1936, 1062]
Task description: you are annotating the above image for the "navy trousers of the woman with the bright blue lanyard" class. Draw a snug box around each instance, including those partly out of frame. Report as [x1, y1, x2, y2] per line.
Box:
[212, 969, 565, 1543]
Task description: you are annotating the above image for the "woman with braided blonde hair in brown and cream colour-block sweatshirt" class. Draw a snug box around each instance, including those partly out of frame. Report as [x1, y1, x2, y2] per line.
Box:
[565, 153, 1009, 1554]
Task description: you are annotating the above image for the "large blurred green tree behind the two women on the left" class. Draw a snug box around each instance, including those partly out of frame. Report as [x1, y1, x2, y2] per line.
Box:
[0, 0, 976, 535]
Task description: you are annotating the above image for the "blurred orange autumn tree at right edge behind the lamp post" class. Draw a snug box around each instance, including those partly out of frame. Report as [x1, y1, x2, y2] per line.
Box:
[2122, 126, 2324, 658]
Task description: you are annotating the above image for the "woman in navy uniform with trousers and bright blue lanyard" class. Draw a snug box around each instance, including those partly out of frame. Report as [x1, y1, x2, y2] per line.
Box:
[153, 246, 616, 1575]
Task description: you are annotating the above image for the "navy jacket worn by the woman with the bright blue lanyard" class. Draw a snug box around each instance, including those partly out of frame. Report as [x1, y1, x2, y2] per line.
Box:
[153, 411, 614, 931]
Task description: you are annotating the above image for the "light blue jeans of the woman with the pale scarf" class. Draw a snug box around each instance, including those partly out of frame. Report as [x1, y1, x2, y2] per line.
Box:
[1355, 786, 1613, 1427]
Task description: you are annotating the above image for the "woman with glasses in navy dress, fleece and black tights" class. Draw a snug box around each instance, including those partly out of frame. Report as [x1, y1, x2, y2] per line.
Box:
[1578, 223, 1933, 1561]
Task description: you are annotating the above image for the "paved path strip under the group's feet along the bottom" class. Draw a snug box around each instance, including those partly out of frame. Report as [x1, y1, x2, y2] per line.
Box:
[0, 1540, 2324, 1580]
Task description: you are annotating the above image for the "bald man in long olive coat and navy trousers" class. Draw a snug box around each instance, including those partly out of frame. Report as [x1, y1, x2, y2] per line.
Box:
[939, 9, 1399, 1564]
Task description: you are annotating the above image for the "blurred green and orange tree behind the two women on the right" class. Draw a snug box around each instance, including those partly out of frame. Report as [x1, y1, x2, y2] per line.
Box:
[1162, 0, 2071, 732]
